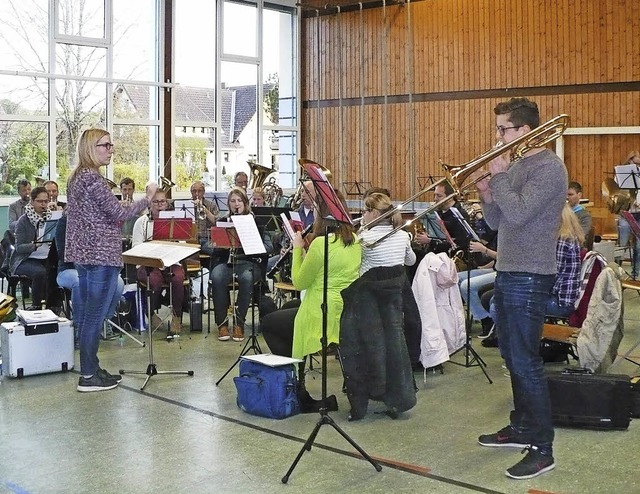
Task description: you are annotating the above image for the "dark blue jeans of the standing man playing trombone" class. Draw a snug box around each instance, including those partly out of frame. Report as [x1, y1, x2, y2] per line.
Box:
[493, 271, 555, 454]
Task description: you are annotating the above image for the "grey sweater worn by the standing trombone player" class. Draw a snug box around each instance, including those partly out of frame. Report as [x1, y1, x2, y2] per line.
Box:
[482, 149, 568, 274]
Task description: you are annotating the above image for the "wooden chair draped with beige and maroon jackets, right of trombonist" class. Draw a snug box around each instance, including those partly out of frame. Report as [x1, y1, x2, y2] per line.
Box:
[542, 252, 623, 372]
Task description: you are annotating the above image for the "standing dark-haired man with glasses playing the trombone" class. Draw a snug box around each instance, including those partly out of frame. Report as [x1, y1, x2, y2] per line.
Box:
[477, 98, 568, 479]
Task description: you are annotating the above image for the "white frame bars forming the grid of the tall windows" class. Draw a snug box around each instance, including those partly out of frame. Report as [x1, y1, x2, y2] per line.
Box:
[0, 0, 300, 197]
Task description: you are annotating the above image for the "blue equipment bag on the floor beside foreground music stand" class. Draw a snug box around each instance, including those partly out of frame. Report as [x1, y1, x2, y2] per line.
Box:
[233, 359, 300, 419]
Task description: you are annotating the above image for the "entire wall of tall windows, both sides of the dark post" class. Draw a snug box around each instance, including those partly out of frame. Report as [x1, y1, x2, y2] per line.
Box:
[0, 0, 298, 199]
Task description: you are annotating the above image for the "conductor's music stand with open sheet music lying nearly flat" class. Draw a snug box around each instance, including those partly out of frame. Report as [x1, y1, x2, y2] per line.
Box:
[120, 240, 200, 391]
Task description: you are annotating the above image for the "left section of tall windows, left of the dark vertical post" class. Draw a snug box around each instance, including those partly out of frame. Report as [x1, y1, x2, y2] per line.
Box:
[0, 0, 161, 193]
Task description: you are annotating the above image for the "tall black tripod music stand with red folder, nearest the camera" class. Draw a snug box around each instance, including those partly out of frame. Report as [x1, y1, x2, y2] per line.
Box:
[282, 160, 382, 484]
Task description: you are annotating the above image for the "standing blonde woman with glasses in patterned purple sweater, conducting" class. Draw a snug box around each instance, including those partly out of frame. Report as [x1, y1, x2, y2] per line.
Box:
[65, 129, 157, 393]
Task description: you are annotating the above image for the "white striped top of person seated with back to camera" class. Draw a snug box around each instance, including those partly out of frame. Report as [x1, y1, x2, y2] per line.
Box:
[359, 225, 416, 276]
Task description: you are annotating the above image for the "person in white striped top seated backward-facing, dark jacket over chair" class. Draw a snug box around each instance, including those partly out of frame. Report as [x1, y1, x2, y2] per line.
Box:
[340, 193, 420, 420]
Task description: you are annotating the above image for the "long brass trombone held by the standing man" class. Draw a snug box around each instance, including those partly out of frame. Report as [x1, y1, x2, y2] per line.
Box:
[362, 114, 569, 247]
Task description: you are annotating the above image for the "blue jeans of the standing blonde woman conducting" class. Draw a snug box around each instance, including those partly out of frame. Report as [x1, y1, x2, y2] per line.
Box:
[76, 264, 120, 376]
